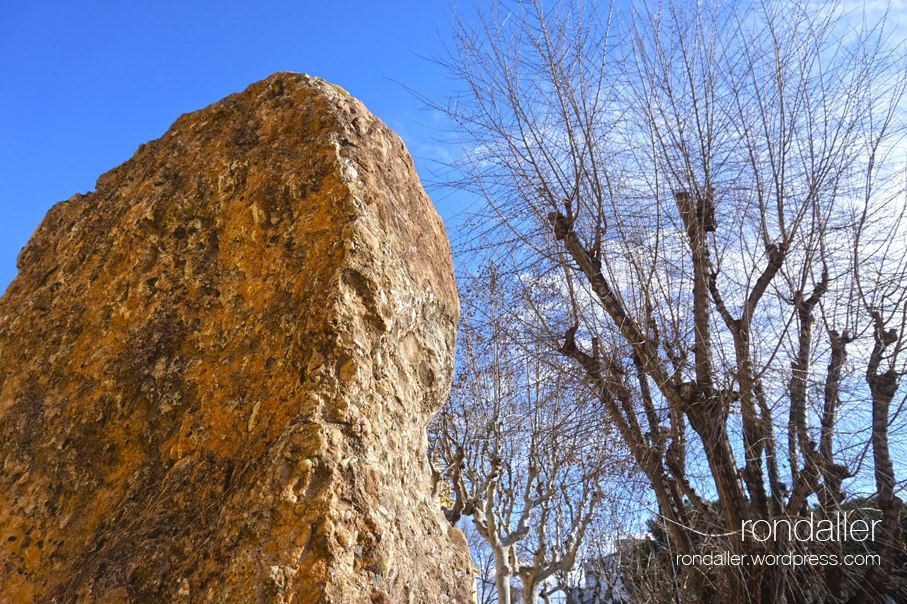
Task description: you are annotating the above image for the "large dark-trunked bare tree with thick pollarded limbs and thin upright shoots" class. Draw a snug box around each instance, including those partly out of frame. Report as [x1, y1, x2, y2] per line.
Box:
[433, 0, 907, 602]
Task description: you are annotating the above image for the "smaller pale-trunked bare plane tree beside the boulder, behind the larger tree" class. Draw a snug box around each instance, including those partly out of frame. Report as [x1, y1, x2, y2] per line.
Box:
[430, 266, 618, 604]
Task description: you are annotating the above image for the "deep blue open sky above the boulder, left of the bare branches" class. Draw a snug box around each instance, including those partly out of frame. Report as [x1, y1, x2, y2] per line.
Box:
[0, 0, 464, 292]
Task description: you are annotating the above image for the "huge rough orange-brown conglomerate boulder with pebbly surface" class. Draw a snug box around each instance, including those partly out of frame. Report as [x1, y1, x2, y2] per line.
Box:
[0, 73, 472, 604]
